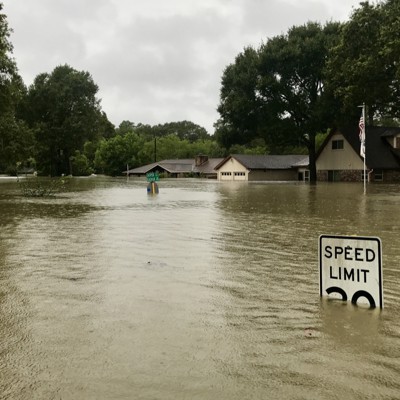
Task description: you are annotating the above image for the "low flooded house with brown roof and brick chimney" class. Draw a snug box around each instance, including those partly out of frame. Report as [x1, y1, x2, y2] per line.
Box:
[124, 155, 222, 179]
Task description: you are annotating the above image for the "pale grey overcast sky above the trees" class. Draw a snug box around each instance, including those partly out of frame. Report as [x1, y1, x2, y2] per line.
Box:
[3, 0, 359, 133]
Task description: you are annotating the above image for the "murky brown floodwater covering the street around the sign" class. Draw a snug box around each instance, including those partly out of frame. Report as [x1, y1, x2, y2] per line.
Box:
[0, 177, 400, 400]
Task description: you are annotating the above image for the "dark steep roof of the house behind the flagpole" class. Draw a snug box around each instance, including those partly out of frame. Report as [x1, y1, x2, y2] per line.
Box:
[317, 126, 400, 169]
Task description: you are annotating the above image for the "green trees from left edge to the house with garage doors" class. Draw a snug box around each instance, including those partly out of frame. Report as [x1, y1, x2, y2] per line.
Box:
[0, 3, 224, 176]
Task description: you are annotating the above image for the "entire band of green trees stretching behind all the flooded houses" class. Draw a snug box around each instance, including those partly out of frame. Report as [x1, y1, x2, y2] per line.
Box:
[0, 0, 400, 180]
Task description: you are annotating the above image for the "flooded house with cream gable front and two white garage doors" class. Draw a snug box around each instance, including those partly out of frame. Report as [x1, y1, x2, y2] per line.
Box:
[215, 154, 309, 181]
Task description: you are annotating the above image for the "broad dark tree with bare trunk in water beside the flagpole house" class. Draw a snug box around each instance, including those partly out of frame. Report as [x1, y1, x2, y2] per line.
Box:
[216, 22, 340, 181]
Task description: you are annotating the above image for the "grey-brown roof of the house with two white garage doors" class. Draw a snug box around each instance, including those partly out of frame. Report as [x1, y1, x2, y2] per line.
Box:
[215, 154, 309, 170]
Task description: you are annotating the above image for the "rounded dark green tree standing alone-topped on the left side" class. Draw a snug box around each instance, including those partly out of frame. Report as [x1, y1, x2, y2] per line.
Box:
[24, 65, 110, 175]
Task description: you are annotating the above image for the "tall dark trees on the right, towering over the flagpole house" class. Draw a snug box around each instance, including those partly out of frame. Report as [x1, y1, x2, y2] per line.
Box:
[215, 0, 400, 181]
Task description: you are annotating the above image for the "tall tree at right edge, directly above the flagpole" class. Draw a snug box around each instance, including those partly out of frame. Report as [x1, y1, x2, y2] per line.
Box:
[327, 0, 400, 125]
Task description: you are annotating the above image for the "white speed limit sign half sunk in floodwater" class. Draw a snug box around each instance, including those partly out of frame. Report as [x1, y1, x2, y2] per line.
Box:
[319, 235, 383, 308]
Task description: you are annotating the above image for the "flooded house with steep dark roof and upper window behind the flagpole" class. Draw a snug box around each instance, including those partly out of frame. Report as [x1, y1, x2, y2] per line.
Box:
[316, 127, 400, 182]
